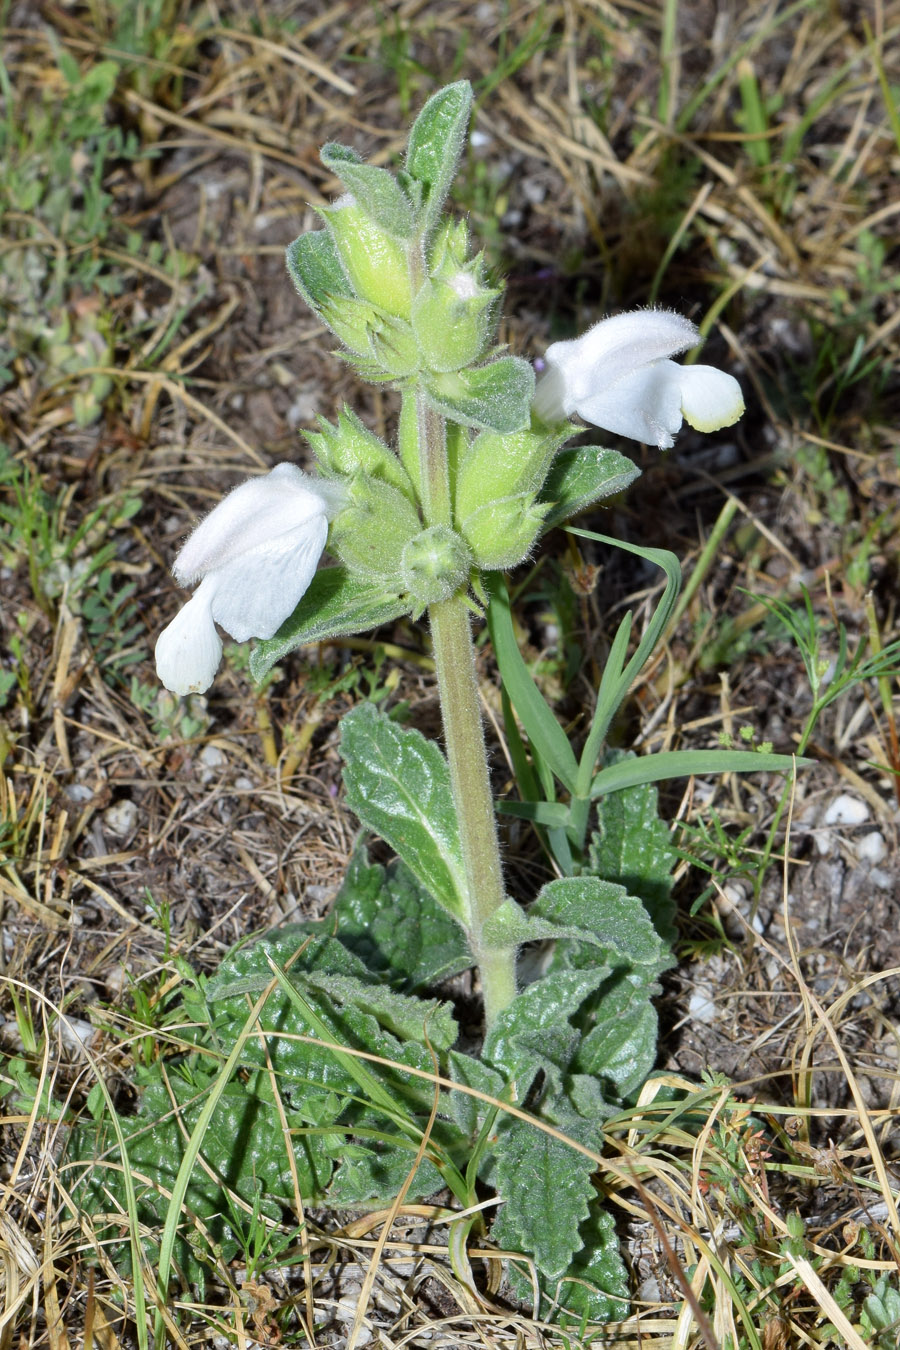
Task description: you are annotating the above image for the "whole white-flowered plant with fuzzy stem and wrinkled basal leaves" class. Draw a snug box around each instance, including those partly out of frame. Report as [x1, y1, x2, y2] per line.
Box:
[107, 82, 791, 1318]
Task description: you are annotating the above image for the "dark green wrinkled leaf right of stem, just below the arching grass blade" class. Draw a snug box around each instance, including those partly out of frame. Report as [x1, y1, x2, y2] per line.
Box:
[590, 755, 677, 942]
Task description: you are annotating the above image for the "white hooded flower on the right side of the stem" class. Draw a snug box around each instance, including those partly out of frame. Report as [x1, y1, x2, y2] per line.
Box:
[534, 309, 743, 450]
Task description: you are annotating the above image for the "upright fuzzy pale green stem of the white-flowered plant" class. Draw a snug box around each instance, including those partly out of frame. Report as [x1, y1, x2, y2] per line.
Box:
[406, 393, 515, 1029]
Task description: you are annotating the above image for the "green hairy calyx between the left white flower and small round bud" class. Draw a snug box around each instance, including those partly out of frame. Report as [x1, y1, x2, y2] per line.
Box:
[328, 474, 422, 585]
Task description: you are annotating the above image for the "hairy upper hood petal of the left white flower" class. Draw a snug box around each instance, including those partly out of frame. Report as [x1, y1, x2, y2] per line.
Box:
[173, 464, 335, 586]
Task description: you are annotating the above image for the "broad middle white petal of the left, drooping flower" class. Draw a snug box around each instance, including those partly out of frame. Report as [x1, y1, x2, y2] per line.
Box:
[201, 514, 328, 643]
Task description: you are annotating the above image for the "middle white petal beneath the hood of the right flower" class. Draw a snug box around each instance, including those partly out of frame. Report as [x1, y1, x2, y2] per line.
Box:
[576, 360, 684, 450]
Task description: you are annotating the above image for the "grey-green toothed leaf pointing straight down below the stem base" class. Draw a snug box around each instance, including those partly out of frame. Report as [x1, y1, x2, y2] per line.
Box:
[491, 1119, 596, 1280]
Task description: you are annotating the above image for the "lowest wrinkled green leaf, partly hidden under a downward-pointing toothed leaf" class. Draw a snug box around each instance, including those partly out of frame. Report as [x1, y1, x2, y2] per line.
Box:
[504, 1202, 629, 1317]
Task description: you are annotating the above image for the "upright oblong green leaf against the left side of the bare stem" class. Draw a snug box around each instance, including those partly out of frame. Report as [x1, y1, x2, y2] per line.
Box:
[340, 703, 468, 922]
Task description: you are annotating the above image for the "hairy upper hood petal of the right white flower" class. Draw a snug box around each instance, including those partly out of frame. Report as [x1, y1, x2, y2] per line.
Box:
[538, 309, 700, 418]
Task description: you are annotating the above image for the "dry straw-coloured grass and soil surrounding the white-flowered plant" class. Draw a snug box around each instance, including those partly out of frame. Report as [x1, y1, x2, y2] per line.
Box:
[0, 0, 900, 1350]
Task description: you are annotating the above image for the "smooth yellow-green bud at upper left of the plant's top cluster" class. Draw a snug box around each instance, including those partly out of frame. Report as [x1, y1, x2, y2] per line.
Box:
[321, 193, 413, 319]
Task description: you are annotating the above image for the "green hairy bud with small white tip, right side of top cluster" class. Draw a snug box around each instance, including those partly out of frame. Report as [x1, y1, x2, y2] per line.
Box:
[413, 267, 501, 371]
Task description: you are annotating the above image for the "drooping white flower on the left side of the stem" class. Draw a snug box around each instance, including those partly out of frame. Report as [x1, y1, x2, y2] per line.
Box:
[157, 464, 340, 694]
